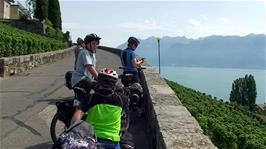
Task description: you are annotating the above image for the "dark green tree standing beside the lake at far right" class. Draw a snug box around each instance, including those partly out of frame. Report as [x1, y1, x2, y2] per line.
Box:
[230, 75, 257, 110]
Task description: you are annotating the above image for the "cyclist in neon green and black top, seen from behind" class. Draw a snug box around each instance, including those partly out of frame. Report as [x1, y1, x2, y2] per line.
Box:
[72, 68, 127, 149]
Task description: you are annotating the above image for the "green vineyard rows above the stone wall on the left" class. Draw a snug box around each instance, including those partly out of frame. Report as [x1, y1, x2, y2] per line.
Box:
[0, 23, 67, 57]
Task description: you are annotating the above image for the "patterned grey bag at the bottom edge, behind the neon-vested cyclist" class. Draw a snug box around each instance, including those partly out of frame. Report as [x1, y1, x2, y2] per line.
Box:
[57, 121, 97, 149]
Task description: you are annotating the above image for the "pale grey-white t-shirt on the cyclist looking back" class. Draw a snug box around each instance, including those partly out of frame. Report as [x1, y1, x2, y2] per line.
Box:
[71, 49, 96, 86]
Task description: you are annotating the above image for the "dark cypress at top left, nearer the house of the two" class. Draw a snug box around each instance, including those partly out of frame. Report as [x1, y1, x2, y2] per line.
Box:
[34, 0, 48, 21]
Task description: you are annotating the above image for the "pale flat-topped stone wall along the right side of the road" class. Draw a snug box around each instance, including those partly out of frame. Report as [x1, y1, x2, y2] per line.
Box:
[102, 47, 217, 149]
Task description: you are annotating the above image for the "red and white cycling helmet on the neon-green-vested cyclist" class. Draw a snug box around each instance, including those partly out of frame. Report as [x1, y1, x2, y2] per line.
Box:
[98, 67, 118, 88]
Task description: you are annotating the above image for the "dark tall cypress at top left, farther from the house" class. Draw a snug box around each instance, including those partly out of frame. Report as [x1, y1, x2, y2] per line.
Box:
[48, 0, 62, 30]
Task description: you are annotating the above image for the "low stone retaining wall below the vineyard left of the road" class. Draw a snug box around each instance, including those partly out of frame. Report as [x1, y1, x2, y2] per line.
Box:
[0, 47, 74, 77]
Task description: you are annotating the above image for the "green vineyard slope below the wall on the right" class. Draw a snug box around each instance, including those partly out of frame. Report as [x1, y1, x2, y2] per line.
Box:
[166, 80, 266, 149]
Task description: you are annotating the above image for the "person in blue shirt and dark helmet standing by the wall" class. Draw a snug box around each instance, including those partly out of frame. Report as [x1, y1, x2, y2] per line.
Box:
[121, 37, 143, 86]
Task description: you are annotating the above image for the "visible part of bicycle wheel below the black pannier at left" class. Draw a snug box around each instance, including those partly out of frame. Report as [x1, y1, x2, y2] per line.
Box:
[50, 112, 67, 143]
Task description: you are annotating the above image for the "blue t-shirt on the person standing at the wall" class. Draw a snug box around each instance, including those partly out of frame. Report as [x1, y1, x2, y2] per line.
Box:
[121, 48, 138, 74]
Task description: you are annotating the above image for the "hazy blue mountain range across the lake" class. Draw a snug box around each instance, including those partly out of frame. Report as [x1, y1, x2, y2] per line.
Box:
[118, 34, 266, 69]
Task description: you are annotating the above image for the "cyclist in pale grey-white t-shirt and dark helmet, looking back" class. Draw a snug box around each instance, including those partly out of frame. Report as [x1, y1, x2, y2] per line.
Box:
[71, 34, 101, 100]
